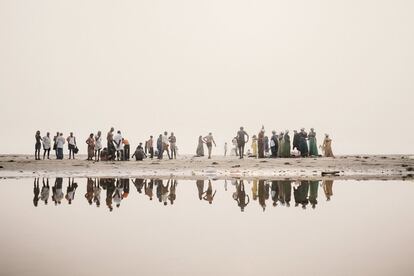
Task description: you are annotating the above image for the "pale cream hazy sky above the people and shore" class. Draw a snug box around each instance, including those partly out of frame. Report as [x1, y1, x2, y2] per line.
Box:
[0, 0, 414, 154]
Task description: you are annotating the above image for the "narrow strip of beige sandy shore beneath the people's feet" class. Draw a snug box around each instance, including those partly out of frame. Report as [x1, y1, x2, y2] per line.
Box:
[0, 155, 414, 180]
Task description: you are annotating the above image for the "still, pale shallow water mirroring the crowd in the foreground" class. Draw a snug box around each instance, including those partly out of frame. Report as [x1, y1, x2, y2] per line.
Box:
[0, 178, 414, 275]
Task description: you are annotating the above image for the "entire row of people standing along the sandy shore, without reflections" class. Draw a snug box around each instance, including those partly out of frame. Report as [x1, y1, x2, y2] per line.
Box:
[35, 126, 334, 161]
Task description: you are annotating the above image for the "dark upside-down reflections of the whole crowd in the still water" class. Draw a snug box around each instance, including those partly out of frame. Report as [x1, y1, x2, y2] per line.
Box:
[33, 177, 333, 212]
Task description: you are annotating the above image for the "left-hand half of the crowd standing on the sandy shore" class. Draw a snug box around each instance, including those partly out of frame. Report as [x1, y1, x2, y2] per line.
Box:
[35, 127, 177, 161]
